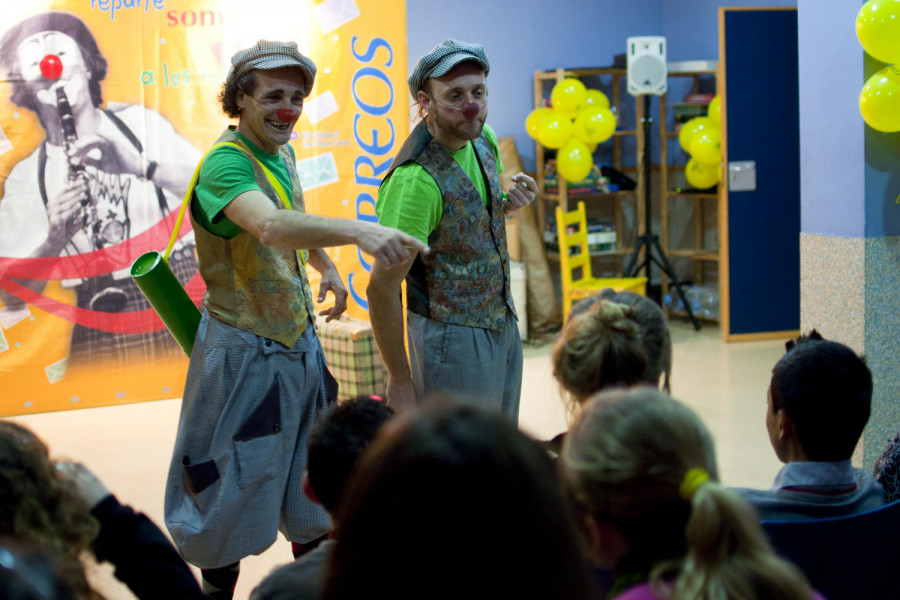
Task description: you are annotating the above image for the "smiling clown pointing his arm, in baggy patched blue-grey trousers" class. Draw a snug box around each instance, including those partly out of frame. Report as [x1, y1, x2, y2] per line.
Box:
[165, 40, 427, 598]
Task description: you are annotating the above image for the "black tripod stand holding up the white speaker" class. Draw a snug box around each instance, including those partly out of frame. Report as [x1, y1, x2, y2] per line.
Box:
[626, 94, 700, 331]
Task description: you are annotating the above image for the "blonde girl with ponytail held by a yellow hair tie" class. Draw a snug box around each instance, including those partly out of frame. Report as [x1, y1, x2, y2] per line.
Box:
[560, 387, 821, 600]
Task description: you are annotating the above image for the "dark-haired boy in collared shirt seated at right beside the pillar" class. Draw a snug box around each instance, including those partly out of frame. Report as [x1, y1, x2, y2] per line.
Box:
[738, 330, 885, 521]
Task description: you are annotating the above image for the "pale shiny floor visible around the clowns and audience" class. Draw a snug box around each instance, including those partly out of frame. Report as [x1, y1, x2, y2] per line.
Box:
[13, 321, 784, 600]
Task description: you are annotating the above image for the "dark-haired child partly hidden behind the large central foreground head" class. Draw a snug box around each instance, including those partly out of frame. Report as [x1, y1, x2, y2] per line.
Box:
[250, 396, 394, 600]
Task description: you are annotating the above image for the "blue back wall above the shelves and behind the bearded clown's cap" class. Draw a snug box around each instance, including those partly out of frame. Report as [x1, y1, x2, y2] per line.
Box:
[406, 0, 796, 171]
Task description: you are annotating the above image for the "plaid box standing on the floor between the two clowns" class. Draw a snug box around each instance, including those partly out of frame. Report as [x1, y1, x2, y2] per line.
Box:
[316, 315, 387, 400]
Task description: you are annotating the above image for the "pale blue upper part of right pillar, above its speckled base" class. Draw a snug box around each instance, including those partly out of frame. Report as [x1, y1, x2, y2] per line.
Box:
[798, 0, 900, 238]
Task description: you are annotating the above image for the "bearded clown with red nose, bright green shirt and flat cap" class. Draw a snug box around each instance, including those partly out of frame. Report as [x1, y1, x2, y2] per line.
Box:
[367, 40, 537, 421]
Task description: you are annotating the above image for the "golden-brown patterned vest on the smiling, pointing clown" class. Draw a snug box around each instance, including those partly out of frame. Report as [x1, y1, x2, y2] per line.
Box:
[191, 128, 315, 347]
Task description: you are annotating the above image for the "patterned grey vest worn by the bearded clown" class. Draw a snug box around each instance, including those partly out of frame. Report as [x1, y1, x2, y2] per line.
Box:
[385, 121, 515, 331]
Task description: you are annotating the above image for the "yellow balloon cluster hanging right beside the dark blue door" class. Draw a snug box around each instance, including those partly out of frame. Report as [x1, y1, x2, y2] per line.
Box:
[678, 96, 722, 190]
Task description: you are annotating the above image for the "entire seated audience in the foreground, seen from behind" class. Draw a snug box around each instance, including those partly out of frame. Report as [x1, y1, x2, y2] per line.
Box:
[7, 290, 900, 600]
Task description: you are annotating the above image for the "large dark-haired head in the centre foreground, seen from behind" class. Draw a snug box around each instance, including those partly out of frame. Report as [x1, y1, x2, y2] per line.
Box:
[326, 403, 587, 599]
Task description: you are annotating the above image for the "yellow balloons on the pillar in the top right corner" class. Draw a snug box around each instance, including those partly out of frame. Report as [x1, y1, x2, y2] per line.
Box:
[856, 0, 900, 132]
